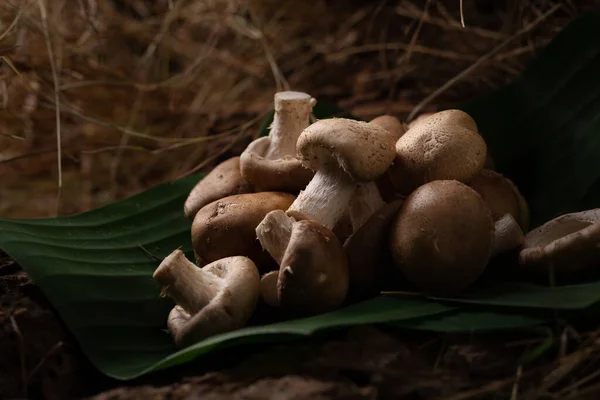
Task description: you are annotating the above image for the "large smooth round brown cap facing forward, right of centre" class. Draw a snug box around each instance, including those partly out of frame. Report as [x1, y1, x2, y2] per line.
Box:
[390, 180, 494, 294]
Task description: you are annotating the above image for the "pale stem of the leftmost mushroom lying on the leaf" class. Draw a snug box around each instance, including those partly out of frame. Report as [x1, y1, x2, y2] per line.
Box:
[152, 250, 223, 315]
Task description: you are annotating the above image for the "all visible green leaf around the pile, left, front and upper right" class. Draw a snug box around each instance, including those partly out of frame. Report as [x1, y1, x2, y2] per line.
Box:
[0, 16, 600, 379]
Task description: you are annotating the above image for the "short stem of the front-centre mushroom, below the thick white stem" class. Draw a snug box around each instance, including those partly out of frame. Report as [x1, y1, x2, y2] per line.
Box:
[256, 210, 294, 265]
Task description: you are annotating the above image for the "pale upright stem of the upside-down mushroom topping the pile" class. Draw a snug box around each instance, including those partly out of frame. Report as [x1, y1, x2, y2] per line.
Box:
[265, 91, 316, 160]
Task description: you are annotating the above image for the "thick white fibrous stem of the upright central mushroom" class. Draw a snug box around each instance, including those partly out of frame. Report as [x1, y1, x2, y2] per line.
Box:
[288, 166, 358, 229]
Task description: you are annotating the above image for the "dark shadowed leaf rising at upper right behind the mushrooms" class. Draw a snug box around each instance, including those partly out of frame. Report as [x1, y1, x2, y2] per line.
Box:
[461, 14, 600, 227]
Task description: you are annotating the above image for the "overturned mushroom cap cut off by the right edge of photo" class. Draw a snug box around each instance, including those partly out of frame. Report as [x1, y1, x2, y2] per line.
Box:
[519, 208, 600, 277]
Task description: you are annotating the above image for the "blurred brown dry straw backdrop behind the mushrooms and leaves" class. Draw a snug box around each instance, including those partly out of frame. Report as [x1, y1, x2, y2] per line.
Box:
[0, 0, 600, 217]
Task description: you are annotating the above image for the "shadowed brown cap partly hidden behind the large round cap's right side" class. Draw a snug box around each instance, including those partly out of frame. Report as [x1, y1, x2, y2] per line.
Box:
[469, 169, 529, 232]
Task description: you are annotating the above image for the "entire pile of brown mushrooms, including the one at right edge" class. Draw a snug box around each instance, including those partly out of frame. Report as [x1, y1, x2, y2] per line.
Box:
[153, 91, 600, 346]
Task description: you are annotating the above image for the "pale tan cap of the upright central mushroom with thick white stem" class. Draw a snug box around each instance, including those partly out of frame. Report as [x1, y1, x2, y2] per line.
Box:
[296, 118, 396, 182]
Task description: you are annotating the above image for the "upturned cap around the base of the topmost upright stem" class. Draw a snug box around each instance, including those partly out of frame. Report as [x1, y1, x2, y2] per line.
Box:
[240, 136, 314, 193]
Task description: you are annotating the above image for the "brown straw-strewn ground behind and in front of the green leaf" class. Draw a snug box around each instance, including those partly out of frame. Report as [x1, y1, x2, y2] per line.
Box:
[0, 0, 600, 399]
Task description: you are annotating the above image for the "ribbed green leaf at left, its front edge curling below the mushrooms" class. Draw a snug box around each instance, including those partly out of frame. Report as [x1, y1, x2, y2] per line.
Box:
[0, 177, 452, 379]
